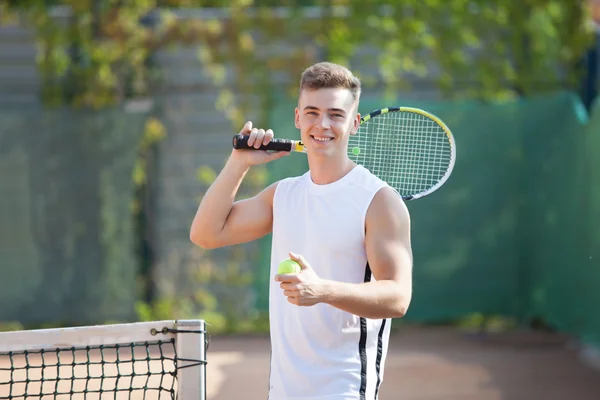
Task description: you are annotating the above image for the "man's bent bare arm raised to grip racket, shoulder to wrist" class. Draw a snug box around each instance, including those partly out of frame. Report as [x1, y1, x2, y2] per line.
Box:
[190, 157, 276, 249]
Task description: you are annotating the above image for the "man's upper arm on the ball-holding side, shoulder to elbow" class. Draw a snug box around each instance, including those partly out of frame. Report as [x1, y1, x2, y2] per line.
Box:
[366, 188, 412, 287]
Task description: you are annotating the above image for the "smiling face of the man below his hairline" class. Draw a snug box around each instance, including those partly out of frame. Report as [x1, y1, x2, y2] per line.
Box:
[296, 88, 360, 156]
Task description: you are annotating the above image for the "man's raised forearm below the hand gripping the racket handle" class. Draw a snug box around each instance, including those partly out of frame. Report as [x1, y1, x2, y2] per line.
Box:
[190, 158, 249, 245]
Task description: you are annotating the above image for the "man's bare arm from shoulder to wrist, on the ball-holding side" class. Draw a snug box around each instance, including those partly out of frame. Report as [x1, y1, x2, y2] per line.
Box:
[322, 188, 412, 319]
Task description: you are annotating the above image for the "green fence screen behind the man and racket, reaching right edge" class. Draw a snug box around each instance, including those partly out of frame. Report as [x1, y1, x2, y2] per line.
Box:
[258, 93, 600, 343]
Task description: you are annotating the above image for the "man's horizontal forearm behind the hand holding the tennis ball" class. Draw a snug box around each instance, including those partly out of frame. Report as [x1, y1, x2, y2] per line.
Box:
[323, 280, 410, 319]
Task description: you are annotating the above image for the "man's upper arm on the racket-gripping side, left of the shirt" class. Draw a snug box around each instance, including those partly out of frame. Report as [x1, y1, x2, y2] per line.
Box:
[222, 183, 276, 244]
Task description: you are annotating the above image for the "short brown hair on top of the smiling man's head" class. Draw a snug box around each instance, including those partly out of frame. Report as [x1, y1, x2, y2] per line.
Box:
[300, 62, 361, 100]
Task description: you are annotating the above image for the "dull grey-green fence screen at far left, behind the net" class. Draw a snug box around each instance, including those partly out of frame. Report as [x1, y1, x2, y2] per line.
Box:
[0, 109, 143, 326]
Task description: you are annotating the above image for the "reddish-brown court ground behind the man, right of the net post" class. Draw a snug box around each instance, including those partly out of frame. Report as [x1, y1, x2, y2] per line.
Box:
[207, 327, 600, 400]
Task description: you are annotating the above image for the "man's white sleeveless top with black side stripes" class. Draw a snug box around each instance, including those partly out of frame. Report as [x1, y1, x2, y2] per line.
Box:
[269, 166, 391, 400]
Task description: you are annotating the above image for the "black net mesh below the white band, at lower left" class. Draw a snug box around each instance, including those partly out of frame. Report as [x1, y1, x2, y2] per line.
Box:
[0, 339, 177, 400]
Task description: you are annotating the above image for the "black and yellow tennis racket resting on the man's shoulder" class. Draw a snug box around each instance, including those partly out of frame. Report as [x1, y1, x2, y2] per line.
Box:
[233, 107, 456, 200]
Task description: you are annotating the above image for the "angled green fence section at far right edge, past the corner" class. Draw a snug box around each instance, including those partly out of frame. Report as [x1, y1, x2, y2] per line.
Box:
[522, 97, 600, 345]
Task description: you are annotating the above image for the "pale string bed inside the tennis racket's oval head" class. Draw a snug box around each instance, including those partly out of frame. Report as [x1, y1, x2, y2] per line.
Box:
[349, 112, 452, 195]
